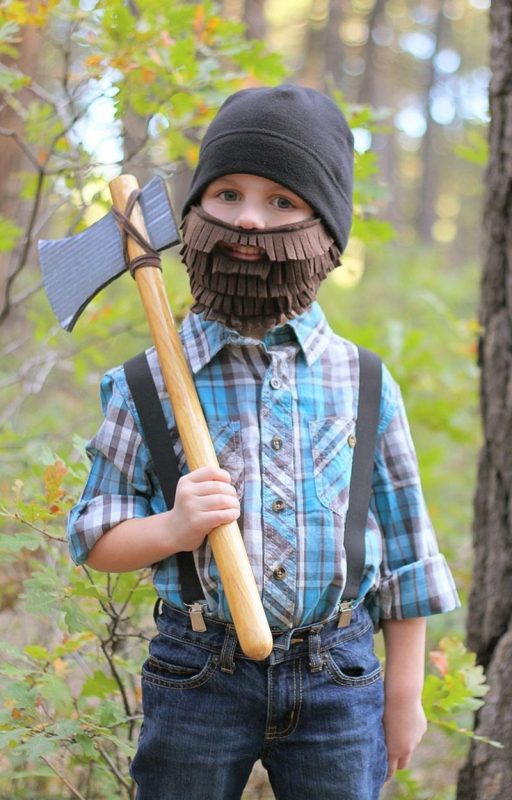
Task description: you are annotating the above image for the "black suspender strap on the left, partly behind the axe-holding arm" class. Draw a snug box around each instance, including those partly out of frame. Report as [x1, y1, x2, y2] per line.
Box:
[124, 353, 204, 605]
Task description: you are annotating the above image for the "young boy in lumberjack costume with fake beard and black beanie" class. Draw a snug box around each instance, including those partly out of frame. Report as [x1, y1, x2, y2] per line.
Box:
[69, 86, 458, 800]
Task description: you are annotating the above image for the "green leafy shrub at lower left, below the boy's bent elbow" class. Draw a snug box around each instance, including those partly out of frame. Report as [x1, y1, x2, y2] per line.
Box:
[0, 457, 154, 800]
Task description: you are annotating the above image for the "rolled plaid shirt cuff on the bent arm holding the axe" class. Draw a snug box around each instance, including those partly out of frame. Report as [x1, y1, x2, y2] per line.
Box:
[68, 495, 152, 564]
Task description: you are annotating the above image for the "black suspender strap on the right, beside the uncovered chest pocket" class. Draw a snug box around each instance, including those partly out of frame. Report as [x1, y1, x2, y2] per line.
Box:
[342, 347, 382, 602]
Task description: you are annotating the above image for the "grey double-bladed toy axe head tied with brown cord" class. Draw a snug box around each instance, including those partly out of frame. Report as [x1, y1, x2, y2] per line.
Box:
[38, 177, 180, 331]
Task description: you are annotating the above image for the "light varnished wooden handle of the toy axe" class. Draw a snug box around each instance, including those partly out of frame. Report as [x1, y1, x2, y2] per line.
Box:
[110, 175, 272, 661]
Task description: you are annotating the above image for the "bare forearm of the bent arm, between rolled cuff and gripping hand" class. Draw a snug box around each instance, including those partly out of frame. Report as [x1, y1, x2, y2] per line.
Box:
[86, 511, 178, 572]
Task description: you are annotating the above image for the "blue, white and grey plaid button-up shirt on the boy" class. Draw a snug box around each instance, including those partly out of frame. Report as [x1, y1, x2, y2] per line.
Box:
[69, 303, 459, 629]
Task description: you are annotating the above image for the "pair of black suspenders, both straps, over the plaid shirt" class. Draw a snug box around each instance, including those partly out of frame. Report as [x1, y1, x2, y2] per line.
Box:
[124, 347, 382, 609]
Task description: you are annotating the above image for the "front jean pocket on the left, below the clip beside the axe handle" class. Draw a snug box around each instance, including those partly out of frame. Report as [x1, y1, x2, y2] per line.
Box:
[142, 634, 219, 689]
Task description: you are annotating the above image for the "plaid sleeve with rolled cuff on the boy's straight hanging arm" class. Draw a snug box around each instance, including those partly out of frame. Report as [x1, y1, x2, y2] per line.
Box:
[372, 384, 460, 619]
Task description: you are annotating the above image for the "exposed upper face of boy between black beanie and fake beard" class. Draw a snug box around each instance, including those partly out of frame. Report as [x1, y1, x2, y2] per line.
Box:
[201, 172, 313, 238]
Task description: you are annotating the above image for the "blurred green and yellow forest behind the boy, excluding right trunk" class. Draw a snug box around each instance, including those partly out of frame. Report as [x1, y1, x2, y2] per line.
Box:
[0, 0, 494, 800]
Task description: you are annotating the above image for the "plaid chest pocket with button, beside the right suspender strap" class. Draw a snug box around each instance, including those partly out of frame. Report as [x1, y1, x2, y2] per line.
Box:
[309, 417, 356, 517]
